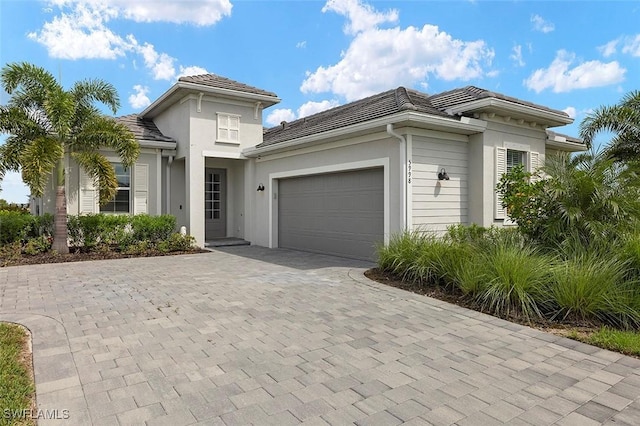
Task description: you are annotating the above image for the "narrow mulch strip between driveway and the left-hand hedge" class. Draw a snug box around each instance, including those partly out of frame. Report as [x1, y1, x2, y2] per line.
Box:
[0, 248, 209, 267]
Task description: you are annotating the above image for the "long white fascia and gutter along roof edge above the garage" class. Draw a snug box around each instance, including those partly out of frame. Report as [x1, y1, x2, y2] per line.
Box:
[242, 112, 487, 158]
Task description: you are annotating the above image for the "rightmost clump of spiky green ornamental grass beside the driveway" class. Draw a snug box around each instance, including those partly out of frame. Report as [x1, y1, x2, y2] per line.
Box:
[548, 255, 640, 327]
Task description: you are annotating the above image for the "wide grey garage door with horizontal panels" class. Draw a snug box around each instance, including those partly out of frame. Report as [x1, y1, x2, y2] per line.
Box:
[278, 168, 384, 260]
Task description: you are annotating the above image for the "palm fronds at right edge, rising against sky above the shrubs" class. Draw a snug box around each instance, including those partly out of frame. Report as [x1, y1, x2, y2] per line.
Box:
[580, 91, 640, 161]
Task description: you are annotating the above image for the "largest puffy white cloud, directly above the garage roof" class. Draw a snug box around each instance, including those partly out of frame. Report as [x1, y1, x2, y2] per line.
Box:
[300, 21, 494, 101]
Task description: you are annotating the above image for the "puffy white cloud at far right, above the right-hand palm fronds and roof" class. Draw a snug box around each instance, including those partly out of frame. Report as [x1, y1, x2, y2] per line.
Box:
[524, 50, 627, 93]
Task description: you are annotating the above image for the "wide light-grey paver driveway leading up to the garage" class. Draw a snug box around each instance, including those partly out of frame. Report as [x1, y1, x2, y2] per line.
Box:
[0, 247, 640, 426]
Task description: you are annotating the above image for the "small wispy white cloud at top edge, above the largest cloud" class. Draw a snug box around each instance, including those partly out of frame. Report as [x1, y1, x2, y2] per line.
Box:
[322, 0, 398, 35]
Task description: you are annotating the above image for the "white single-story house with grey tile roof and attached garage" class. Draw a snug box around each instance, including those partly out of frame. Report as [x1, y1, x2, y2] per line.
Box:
[32, 74, 585, 259]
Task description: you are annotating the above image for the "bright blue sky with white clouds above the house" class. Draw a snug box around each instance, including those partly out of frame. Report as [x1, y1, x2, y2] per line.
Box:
[0, 0, 640, 202]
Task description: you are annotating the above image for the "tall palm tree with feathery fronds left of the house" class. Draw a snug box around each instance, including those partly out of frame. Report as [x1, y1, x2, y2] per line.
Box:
[0, 62, 140, 253]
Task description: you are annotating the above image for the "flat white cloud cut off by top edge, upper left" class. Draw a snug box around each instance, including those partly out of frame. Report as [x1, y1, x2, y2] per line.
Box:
[50, 0, 233, 26]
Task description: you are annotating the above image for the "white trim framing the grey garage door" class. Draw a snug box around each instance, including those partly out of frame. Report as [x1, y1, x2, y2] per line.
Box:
[268, 157, 391, 248]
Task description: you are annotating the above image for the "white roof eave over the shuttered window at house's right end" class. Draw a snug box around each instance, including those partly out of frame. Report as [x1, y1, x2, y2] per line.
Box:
[446, 98, 573, 127]
